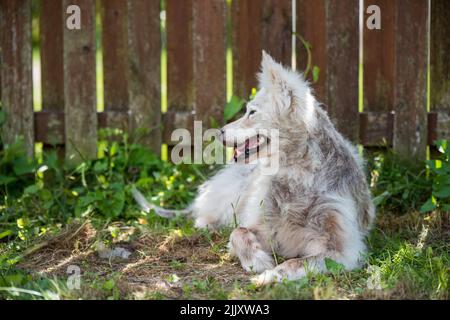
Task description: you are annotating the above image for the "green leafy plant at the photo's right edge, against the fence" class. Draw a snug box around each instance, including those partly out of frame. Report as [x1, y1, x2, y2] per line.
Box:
[420, 140, 450, 212]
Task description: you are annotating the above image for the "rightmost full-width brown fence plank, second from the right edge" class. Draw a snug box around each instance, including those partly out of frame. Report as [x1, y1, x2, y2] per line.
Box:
[393, 0, 428, 159]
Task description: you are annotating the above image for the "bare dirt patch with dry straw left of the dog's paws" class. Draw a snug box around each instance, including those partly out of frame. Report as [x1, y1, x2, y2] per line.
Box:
[18, 223, 249, 299]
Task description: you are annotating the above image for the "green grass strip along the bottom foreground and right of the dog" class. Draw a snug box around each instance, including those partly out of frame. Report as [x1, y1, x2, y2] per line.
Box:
[0, 213, 450, 299]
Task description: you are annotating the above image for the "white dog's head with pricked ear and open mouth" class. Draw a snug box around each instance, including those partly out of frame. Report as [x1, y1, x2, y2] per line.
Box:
[220, 51, 315, 163]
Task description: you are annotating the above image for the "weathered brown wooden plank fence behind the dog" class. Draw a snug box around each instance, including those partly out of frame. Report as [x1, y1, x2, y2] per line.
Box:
[0, 0, 450, 164]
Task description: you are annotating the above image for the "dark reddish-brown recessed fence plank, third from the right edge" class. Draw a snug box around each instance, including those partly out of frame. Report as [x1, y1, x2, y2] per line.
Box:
[360, 0, 395, 146]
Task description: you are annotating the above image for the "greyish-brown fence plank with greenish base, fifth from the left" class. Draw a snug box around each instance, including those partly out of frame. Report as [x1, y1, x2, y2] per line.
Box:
[128, 0, 161, 154]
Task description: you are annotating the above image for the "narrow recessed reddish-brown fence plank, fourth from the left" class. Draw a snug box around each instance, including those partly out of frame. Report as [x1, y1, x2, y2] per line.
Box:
[101, 0, 128, 131]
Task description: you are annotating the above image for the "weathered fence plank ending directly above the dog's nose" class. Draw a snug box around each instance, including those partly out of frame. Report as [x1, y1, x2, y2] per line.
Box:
[193, 0, 226, 128]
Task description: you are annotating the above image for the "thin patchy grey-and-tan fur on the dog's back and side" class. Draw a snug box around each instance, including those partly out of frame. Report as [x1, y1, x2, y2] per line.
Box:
[265, 102, 375, 266]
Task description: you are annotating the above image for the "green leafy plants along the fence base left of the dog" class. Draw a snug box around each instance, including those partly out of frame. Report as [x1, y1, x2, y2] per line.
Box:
[0, 130, 209, 241]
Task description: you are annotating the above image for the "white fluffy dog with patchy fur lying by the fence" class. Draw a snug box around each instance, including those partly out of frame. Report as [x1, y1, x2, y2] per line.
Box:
[136, 52, 375, 285]
